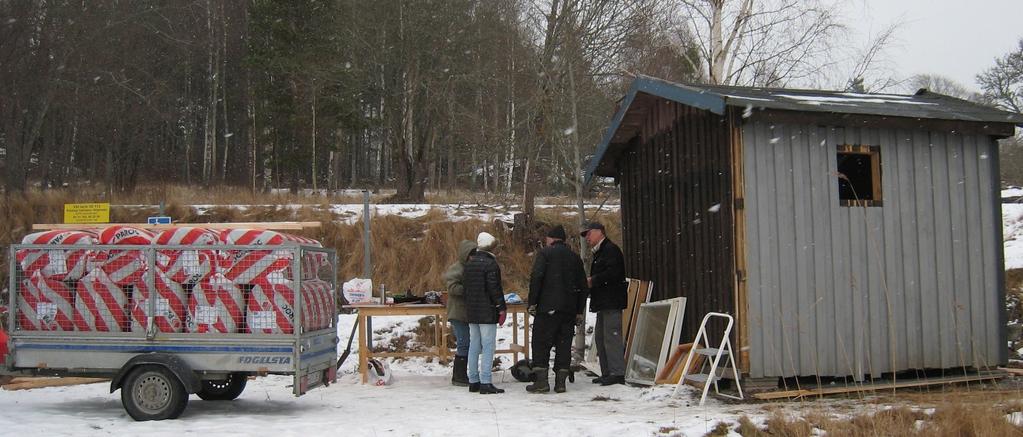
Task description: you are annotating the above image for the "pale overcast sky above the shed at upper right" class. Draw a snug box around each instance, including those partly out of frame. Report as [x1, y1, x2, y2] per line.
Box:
[847, 0, 1023, 90]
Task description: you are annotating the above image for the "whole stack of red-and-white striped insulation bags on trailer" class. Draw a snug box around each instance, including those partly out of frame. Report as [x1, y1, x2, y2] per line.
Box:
[15, 226, 335, 334]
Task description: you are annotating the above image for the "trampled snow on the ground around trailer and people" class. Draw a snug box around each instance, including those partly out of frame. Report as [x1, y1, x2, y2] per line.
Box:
[0, 315, 764, 437]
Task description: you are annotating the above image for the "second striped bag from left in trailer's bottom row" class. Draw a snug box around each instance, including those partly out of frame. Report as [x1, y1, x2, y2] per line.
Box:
[74, 269, 128, 333]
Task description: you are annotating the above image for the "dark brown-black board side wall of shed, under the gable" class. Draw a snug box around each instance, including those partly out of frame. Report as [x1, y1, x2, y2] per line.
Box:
[618, 99, 735, 342]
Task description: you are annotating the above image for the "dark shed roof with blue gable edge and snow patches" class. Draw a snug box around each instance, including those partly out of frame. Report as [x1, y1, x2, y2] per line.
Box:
[586, 76, 1023, 184]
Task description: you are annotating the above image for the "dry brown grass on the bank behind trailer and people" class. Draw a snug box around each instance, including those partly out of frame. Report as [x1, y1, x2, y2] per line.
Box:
[0, 185, 621, 307]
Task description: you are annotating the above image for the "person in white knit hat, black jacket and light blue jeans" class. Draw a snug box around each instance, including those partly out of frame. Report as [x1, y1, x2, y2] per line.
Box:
[462, 232, 507, 394]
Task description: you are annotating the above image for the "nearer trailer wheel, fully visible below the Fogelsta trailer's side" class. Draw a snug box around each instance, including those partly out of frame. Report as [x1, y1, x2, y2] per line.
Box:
[121, 364, 188, 422]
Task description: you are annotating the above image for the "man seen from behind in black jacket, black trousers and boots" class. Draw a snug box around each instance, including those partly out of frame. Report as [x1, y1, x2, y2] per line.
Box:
[526, 225, 587, 393]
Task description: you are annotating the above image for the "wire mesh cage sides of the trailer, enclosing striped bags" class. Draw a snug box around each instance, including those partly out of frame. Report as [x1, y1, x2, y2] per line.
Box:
[8, 242, 337, 337]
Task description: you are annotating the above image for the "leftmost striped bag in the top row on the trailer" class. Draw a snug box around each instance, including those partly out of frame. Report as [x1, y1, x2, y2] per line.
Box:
[14, 230, 99, 280]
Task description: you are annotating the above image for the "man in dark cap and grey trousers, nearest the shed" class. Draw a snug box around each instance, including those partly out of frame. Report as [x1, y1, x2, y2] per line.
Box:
[579, 222, 628, 386]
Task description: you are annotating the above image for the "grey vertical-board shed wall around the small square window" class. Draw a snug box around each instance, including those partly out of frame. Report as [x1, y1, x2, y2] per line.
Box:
[743, 122, 1006, 379]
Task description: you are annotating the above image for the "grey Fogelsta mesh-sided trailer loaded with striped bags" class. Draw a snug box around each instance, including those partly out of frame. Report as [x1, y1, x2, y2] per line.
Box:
[0, 242, 338, 421]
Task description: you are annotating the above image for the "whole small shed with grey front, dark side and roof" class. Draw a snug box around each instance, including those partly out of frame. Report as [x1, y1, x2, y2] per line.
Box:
[587, 77, 1023, 381]
